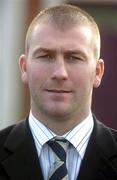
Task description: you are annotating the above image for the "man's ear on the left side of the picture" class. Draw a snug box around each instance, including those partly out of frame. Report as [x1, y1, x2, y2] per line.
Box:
[19, 54, 27, 84]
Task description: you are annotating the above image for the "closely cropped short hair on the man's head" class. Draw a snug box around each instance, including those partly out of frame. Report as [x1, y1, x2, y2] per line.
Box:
[25, 5, 100, 59]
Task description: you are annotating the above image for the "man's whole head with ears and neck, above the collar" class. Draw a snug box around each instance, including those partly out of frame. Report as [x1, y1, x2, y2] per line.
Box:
[20, 5, 104, 131]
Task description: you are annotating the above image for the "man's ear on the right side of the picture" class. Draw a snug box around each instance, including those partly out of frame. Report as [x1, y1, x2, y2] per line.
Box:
[94, 59, 104, 88]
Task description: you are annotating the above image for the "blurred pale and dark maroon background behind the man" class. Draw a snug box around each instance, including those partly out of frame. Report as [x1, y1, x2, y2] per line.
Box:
[0, 0, 117, 129]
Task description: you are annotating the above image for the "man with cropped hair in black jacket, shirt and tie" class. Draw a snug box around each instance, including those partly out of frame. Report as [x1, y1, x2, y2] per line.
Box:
[0, 5, 117, 180]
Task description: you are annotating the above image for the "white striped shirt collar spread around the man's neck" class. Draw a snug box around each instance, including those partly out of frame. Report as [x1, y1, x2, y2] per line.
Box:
[29, 112, 94, 157]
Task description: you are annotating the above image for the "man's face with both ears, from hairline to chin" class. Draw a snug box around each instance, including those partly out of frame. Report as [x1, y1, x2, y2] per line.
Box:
[20, 24, 103, 122]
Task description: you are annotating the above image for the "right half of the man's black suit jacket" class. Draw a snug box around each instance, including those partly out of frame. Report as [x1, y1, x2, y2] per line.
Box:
[78, 118, 117, 180]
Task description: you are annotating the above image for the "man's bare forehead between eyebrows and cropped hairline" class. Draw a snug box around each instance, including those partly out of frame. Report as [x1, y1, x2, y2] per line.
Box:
[30, 24, 92, 48]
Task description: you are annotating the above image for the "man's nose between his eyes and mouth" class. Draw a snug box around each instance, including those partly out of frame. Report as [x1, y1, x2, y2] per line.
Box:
[52, 58, 68, 80]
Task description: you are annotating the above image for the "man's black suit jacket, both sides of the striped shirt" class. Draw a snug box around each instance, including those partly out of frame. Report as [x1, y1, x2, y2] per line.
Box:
[0, 116, 117, 180]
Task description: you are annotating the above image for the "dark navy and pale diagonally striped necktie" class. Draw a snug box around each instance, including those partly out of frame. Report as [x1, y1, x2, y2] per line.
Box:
[48, 139, 69, 180]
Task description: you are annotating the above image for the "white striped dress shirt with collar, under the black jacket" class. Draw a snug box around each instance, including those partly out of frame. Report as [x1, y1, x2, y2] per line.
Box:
[29, 112, 94, 180]
